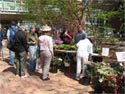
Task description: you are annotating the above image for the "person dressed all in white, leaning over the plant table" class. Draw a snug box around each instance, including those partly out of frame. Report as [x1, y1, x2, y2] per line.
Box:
[75, 38, 93, 81]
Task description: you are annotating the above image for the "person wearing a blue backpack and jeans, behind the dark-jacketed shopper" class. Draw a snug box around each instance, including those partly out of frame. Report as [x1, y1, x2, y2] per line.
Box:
[7, 21, 18, 65]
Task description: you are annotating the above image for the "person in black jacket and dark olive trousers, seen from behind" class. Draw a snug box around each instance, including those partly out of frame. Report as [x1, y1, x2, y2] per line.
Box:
[14, 26, 28, 78]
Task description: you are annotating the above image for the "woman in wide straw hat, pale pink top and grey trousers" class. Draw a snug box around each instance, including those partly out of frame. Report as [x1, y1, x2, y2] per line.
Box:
[39, 25, 53, 81]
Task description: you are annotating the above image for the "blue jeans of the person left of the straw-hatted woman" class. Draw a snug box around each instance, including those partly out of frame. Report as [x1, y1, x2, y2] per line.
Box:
[29, 46, 37, 71]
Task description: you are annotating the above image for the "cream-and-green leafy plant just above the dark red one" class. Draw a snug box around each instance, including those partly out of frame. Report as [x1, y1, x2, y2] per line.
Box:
[87, 62, 118, 82]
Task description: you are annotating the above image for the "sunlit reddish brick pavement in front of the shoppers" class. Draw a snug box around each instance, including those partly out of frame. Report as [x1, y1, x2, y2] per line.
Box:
[0, 41, 93, 94]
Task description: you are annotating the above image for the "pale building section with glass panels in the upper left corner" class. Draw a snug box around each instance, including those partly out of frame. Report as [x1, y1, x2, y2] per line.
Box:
[0, 0, 28, 26]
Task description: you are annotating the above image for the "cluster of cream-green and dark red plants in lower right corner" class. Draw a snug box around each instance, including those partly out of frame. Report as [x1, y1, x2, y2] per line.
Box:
[87, 62, 124, 94]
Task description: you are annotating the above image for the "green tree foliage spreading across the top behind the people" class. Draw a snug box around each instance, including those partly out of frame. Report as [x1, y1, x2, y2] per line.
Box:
[25, 0, 125, 43]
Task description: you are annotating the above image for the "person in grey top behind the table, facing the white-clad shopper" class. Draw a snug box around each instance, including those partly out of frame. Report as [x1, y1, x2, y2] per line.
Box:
[74, 25, 87, 44]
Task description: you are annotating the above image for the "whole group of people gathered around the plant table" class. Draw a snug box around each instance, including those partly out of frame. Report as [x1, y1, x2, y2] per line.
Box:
[0, 21, 93, 81]
